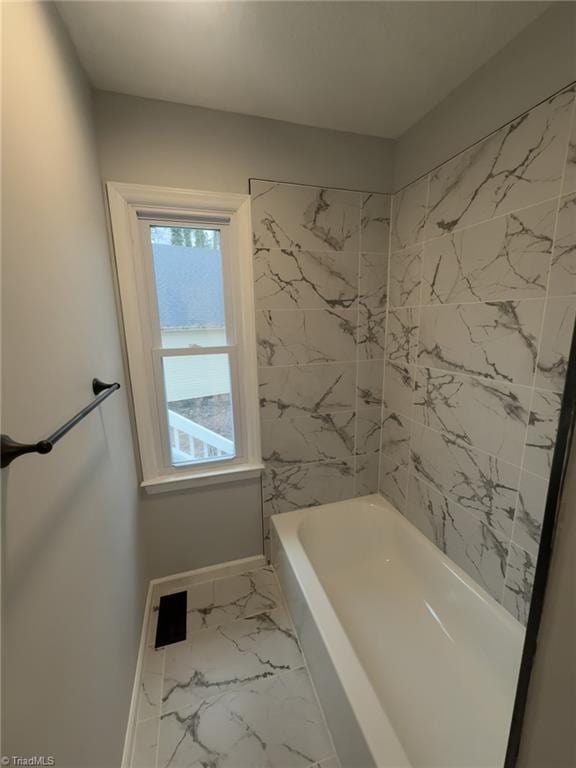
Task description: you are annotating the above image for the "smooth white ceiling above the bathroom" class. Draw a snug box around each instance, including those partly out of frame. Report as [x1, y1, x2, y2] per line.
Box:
[58, 0, 549, 138]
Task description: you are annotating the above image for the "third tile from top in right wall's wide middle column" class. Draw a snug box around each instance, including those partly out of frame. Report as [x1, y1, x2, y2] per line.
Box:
[418, 299, 544, 386]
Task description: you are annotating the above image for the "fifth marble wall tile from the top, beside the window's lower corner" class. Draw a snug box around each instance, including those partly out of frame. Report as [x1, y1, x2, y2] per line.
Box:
[262, 411, 355, 466]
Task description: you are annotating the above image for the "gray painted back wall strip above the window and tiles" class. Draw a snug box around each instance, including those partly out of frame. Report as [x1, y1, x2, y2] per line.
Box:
[94, 91, 393, 193]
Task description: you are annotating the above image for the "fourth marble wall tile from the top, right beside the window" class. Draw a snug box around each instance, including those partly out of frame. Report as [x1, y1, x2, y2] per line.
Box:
[258, 363, 356, 419]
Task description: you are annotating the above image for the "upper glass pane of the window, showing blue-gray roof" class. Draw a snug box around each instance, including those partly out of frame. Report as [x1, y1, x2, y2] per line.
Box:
[150, 226, 227, 349]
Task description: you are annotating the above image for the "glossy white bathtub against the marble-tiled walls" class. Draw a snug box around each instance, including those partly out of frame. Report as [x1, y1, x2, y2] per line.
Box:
[272, 495, 524, 768]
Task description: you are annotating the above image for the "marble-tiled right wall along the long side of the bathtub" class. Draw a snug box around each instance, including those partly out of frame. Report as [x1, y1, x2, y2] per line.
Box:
[382, 89, 576, 623]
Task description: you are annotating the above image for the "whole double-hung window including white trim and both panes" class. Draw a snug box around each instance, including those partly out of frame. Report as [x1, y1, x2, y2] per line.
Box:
[108, 184, 262, 491]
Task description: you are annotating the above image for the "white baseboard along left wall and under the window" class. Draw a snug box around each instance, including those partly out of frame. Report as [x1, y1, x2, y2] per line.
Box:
[122, 555, 267, 768]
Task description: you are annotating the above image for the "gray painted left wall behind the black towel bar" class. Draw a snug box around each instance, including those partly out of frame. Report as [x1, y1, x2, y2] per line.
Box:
[2, 3, 146, 768]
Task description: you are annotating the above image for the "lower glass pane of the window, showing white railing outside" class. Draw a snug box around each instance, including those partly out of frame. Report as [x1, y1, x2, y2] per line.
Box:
[162, 355, 235, 466]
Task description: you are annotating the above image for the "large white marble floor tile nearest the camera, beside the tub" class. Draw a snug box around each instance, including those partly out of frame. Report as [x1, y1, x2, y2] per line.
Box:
[158, 669, 333, 768]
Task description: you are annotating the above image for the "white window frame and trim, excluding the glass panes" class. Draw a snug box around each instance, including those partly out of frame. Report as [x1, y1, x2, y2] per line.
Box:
[106, 182, 263, 493]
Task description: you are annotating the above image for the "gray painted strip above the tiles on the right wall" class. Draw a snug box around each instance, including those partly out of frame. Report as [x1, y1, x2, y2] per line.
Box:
[394, 2, 576, 190]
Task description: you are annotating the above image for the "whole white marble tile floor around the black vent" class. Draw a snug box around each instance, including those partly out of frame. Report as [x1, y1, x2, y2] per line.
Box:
[131, 567, 339, 768]
